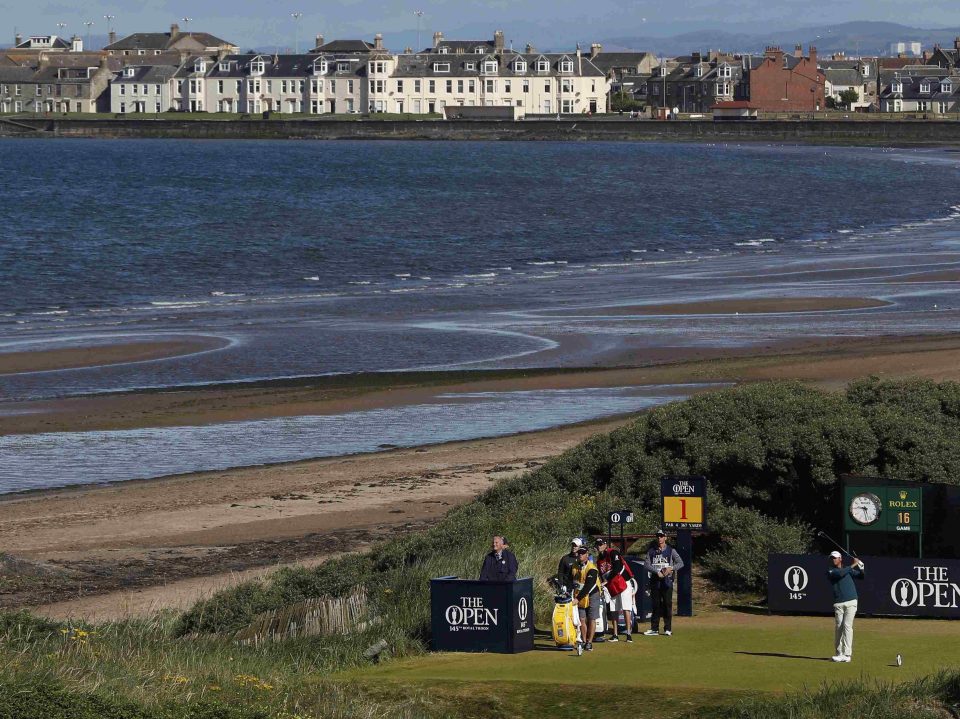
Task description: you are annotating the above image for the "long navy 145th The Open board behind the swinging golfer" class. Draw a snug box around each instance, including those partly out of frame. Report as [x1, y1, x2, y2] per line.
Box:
[767, 554, 960, 619]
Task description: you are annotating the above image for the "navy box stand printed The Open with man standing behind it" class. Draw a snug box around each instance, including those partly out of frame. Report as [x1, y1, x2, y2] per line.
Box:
[430, 577, 533, 654]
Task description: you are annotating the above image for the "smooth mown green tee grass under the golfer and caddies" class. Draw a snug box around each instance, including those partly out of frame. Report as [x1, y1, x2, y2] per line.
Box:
[344, 610, 960, 717]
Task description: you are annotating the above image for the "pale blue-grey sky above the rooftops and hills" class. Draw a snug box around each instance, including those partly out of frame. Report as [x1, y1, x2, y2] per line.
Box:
[0, 0, 960, 50]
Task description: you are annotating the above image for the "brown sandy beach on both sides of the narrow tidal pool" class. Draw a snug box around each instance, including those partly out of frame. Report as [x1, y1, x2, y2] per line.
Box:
[0, 336, 960, 618]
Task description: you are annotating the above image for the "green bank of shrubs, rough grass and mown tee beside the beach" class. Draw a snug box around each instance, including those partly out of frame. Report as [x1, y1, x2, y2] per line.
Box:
[0, 380, 960, 719]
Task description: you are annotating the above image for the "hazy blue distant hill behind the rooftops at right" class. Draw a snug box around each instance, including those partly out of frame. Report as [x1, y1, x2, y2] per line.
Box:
[601, 21, 960, 56]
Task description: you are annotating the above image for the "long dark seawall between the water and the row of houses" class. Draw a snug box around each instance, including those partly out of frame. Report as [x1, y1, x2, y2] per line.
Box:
[0, 118, 960, 146]
